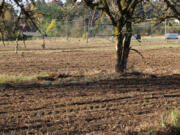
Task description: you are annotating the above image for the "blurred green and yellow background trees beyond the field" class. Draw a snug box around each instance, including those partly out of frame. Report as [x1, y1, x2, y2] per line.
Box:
[0, 0, 180, 40]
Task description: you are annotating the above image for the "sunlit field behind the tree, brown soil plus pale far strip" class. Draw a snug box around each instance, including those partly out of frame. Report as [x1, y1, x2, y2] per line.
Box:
[0, 38, 180, 75]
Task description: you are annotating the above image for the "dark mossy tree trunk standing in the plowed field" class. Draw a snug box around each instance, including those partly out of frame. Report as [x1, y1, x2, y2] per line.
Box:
[115, 22, 132, 73]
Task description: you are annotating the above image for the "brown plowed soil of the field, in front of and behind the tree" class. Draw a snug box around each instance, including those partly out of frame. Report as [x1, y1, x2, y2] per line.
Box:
[0, 40, 180, 135]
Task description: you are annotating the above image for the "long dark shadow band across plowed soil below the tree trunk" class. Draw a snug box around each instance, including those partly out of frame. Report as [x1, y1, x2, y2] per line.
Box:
[1, 72, 180, 92]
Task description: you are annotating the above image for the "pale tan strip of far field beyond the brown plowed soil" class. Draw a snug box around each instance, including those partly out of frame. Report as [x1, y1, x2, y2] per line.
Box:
[0, 37, 180, 53]
